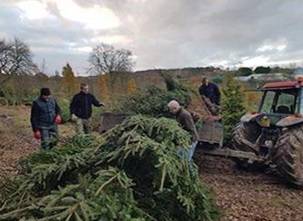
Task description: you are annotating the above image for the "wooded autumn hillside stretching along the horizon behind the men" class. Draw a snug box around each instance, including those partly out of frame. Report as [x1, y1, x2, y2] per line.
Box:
[0, 67, 294, 111]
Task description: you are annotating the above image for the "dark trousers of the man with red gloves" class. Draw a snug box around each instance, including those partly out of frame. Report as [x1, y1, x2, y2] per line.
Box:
[40, 125, 58, 150]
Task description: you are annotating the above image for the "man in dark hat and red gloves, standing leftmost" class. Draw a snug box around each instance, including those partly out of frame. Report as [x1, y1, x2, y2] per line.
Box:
[31, 88, 62, 150]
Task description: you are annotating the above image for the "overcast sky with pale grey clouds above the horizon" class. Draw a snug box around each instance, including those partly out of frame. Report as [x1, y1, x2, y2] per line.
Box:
[0, 0, 303, 74]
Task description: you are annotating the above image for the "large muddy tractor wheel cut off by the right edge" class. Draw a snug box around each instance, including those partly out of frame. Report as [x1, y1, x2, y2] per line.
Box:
[273, 125, 303, 187]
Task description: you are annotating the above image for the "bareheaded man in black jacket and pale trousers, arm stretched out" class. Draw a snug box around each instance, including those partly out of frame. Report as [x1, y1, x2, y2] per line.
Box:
[70, 83, 104, 134]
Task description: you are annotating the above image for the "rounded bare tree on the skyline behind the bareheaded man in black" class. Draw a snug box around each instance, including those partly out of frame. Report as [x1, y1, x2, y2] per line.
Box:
[88, 43, 134, 74]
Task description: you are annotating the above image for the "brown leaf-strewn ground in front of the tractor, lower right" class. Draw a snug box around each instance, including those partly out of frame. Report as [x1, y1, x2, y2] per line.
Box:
[198, 154, 303, 221]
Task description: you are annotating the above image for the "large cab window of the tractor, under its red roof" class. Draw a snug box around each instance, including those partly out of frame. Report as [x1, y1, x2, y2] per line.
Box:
[261, 90, 297, 114]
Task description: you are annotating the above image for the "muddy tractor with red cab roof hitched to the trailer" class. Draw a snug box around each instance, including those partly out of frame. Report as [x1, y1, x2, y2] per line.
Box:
[230, 80, 303, 186]
